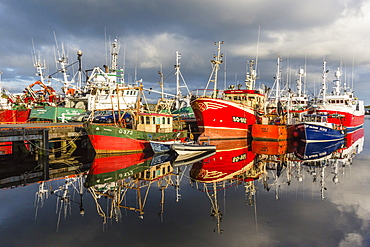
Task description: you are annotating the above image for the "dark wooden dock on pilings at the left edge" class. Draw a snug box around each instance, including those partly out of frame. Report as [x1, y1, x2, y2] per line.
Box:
[0, 122, 94, 180]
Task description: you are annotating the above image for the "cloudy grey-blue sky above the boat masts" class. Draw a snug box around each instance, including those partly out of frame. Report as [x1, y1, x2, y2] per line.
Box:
[0, 0, 370, 104]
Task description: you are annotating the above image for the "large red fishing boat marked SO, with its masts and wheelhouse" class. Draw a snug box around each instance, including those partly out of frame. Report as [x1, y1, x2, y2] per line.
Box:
[191, 42, 265, 140]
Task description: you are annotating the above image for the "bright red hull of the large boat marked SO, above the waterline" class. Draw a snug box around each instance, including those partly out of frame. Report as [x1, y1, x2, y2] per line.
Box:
[191, 98, 257, 140]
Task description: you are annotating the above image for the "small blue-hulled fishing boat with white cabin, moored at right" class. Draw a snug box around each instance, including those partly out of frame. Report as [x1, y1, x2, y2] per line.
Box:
[294, 113, 346, 142]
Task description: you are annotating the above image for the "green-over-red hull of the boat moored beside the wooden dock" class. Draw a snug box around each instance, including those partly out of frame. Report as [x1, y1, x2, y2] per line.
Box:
[84, 123, 187, 153]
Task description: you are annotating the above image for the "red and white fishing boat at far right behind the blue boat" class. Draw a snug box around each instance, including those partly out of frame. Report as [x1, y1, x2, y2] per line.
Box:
[316, 61, 365, 132]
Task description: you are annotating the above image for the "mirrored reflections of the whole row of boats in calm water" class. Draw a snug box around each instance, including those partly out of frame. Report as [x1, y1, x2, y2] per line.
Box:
[0, 129, 364, 237]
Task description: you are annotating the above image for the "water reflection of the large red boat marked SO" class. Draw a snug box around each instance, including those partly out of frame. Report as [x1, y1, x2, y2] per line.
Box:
[190, 140, 265, 233]
